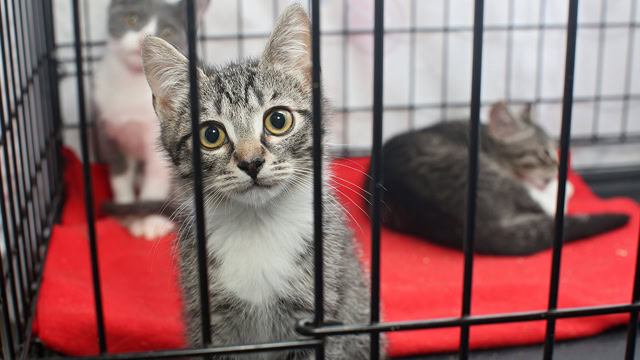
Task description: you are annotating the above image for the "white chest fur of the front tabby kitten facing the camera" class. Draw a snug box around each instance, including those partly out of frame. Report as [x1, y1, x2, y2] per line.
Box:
[207, 190, 313, 305]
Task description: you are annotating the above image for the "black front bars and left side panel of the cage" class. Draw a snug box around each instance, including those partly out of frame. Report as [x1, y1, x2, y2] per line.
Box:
[0, 0, 640, 360]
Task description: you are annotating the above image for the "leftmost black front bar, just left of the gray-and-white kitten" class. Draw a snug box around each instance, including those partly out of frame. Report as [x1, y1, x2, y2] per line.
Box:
[73, 0, 107, 354]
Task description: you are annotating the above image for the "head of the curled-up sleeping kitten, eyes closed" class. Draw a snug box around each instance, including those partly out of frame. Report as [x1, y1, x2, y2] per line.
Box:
[489, 104, 559, 188]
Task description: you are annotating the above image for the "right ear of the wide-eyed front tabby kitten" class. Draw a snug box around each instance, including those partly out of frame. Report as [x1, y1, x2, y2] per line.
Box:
[260, 5, 311, 83]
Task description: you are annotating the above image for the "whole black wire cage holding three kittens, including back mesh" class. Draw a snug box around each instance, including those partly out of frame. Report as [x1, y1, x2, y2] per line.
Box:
[0, 0, 640, 359]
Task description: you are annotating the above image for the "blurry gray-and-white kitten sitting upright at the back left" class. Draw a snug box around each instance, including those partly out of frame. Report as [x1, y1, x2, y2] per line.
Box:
[92, 0, 208, 239]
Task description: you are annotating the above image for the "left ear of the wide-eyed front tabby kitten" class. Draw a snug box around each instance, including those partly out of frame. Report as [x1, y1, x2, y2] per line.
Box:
[142, 36, 204, 116]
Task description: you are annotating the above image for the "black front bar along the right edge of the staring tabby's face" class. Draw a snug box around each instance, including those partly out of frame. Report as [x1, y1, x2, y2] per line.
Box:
[311, 0, 324, 360]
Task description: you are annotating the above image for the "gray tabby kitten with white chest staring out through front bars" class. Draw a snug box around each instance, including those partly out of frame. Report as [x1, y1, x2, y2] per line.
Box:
[142, 5, 382, 359]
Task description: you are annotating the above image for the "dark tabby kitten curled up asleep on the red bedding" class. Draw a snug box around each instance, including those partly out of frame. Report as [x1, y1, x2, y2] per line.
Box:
[368, 103, 629, 255]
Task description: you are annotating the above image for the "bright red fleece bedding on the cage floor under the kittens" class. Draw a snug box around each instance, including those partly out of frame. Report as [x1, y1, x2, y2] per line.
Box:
[34, 151, 640, 356]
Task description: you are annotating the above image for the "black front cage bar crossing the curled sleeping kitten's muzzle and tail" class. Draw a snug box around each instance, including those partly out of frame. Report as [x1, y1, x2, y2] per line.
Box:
[543, 0, 578, 360]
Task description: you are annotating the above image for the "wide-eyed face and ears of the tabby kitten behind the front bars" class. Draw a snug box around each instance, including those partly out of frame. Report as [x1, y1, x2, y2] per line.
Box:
[143, 6, 313, 206]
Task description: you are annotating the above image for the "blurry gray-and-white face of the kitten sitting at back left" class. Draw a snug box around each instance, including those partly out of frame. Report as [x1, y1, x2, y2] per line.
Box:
[108, 0, 208, 71]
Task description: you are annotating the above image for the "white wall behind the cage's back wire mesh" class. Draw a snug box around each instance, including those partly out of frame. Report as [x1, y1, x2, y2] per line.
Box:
[54, 0, 640, 166]
